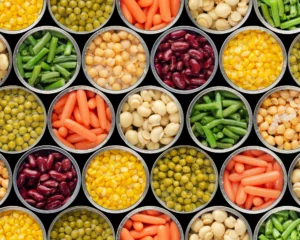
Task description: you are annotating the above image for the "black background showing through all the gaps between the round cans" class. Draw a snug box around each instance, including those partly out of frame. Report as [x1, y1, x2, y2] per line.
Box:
[0, 2, 298, 237]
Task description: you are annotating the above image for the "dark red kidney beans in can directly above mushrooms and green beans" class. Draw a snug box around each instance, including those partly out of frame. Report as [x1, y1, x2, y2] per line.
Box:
[154, 30, 215, 90]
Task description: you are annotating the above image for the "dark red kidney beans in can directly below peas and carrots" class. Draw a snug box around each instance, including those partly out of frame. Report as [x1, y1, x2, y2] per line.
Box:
[17, 150, 77, 210]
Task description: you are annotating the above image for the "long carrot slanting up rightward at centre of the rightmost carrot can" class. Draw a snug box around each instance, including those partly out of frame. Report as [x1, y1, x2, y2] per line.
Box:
[241, 171, 280, 186]
